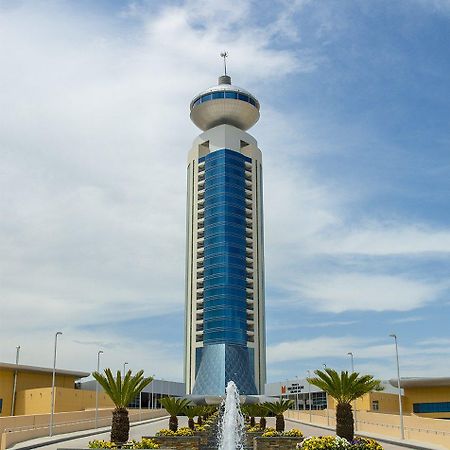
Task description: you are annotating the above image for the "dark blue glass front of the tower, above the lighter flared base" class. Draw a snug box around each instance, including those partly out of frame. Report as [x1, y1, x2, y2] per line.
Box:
[203, 149, 251, 346]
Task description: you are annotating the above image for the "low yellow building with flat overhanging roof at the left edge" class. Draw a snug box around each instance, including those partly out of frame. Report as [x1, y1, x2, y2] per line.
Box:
[0, 363, 112, 416]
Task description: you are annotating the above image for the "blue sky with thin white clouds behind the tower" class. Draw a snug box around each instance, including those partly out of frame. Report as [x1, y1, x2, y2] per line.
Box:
[0, 0, 450, 382]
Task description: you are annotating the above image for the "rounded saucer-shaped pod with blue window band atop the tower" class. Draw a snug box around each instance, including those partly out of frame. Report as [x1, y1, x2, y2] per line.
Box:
[190, 75, 259, 131]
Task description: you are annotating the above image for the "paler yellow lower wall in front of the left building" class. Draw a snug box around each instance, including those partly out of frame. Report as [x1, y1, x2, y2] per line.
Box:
[16, 388, 114, 415]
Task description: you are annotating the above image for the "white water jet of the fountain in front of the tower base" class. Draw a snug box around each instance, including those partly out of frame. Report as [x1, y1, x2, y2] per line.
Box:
[218, 381, 245, 450]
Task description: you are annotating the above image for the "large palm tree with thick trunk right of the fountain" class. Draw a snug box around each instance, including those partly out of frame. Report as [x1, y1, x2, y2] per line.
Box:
[307, 368, 383, 442]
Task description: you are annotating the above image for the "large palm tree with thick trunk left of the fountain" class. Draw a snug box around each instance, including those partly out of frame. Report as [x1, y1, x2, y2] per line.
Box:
[92, 369, 153, 444]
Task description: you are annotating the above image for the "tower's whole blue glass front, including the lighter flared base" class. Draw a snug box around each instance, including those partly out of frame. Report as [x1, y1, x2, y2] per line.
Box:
[193, 149, 256, 395]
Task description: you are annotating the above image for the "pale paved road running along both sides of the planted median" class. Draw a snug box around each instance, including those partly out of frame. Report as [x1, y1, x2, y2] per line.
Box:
[11, 417, 442, 450]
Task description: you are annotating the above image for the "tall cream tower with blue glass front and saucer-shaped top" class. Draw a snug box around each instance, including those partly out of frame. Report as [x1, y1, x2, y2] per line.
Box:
[185, 68, 266, 395]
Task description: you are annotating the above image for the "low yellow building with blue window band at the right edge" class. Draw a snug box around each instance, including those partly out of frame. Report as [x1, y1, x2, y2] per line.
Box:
[390, 377, 450, 419]
